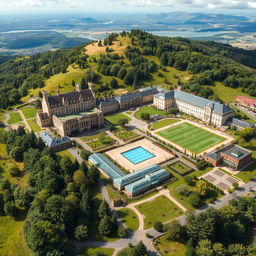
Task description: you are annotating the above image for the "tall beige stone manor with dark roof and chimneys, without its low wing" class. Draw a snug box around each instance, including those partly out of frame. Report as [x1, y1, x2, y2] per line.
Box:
[37, 84, 104, 136]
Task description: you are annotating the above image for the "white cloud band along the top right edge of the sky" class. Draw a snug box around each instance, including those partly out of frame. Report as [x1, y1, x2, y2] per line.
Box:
[112, 0, 256, 9]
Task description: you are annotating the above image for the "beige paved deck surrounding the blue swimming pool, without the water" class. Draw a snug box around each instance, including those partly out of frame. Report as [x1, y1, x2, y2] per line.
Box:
[106, 139, 174, 172]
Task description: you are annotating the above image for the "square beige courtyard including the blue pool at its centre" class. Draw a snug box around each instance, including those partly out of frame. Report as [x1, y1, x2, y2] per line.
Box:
[106, 139, 174, 172]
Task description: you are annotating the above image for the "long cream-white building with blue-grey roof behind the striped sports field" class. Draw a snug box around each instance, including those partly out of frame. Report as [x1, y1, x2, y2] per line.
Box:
[154, 90, 234, 127]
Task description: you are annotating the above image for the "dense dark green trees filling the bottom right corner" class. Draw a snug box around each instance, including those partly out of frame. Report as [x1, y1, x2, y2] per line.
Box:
[165, 198, 256, 256]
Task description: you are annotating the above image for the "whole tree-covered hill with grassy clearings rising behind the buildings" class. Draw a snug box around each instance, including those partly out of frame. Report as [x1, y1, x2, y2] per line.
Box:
[0, 30, 256, 108]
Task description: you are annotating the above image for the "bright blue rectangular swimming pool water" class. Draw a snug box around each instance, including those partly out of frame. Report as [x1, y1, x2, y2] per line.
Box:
[121, 147, 155, 164]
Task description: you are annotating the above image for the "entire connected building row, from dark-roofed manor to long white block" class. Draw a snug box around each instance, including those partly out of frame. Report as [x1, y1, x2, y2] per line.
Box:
[37, 83, 234, 136]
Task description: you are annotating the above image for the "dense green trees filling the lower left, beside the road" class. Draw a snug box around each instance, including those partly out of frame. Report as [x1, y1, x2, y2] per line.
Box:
[0, 127, 126, 256]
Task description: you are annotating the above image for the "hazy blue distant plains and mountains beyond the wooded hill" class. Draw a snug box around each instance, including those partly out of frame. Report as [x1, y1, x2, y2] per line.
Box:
[0, 12, 256, 55]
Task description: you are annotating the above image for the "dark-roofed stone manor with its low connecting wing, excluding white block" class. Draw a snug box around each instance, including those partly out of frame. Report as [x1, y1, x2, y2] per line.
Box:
[37, 83, 162, 136]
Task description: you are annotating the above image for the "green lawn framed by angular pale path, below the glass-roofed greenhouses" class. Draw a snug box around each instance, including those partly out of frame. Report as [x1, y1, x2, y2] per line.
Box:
[136, 196, 183, 229]
